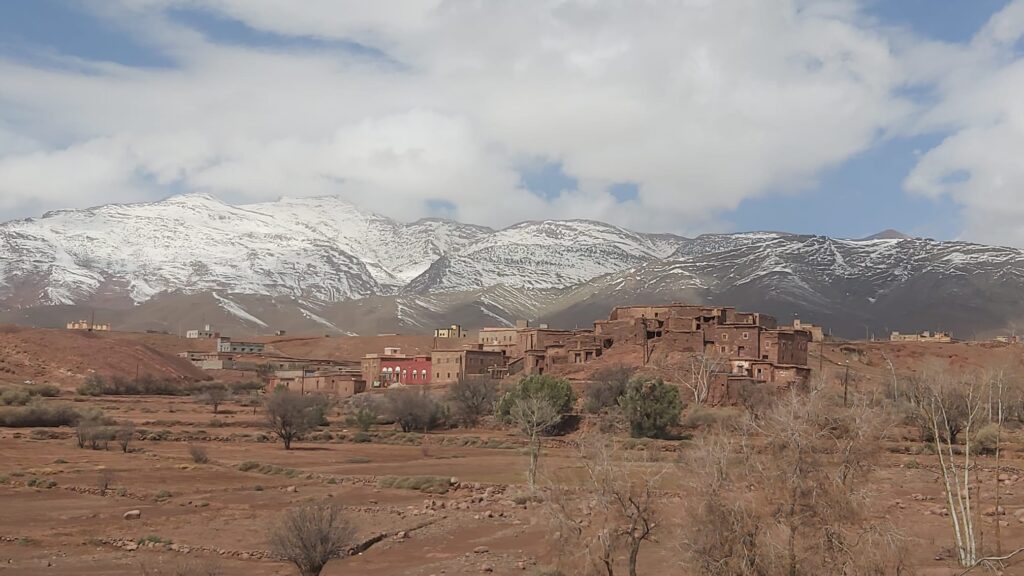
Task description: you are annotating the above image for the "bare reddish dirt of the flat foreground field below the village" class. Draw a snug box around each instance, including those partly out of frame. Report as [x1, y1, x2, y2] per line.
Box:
[0, 389, 1024, 576]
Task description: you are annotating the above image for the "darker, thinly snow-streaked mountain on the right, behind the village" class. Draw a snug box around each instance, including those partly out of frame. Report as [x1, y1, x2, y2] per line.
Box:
[549, 233, 1024, 337]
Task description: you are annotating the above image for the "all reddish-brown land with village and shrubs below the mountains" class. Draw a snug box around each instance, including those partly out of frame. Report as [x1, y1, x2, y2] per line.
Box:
[0, 303, 1024, 576]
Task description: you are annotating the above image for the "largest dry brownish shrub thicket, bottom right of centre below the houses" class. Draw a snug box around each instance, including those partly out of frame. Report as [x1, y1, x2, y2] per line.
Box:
[683, 393, 907, 576]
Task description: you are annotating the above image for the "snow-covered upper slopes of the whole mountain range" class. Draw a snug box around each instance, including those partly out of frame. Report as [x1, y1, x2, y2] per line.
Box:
[6, 195, 1024, 326]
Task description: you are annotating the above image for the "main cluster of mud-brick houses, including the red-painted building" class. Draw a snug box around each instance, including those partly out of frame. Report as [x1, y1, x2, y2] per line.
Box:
[352, 304, 823, 401]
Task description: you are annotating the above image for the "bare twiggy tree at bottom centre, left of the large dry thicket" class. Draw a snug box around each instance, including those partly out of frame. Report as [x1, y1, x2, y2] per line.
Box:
[547, 437, 667, 576]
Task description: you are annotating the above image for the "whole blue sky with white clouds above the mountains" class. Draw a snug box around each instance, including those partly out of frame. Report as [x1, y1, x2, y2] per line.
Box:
[0, 0, 1024, 242]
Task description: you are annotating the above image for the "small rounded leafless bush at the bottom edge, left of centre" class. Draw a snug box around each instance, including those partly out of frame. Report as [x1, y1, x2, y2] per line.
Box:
[270, 503, 355, 576]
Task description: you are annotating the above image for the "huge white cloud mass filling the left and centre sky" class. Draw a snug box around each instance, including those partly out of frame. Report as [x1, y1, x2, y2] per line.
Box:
[0, 0, 913, 233]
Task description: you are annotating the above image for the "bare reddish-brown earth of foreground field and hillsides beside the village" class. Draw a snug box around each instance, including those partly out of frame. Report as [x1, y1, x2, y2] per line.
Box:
[6, 328, 1024, 576]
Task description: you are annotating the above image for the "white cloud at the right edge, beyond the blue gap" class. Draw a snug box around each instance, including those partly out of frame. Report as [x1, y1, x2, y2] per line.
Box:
[904, 0, 1024, 246]
